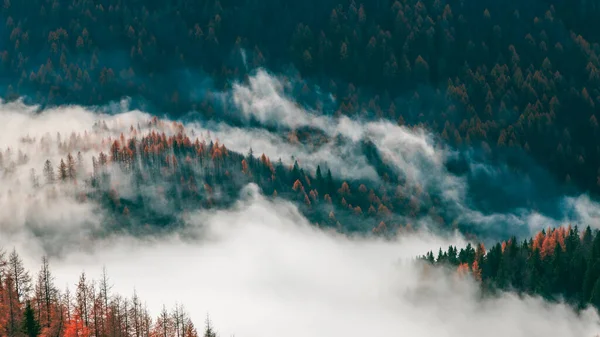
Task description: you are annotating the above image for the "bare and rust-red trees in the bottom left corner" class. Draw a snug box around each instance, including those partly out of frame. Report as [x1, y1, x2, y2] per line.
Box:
[0, 250, 216, 337]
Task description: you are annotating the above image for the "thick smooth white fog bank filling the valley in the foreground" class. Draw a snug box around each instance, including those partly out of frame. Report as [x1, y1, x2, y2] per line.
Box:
[23, 185, 600, 337]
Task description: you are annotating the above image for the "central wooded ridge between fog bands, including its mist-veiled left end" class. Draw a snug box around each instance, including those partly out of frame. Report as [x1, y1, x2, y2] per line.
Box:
[22, 118, 436, 235]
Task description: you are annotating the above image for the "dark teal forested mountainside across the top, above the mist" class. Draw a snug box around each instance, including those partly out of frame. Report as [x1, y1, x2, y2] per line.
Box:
[0, 0, 600, 192]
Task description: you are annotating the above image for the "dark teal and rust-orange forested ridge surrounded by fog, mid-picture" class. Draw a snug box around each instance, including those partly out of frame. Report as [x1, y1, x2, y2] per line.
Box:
[45, 121, 434, 235]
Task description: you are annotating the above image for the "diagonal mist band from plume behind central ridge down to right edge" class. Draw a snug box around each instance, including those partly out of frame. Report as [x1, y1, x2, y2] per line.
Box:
[219, 69, 600, 238]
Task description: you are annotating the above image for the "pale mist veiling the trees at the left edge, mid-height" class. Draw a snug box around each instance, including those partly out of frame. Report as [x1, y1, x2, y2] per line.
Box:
[0, 97, 157, 252]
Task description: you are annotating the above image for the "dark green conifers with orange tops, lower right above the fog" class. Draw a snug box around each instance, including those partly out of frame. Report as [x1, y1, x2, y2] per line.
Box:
[422, 226, 600, 309]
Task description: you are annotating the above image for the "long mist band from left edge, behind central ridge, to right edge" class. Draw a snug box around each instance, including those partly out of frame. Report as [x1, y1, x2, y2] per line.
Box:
[0, 70, 600, 246]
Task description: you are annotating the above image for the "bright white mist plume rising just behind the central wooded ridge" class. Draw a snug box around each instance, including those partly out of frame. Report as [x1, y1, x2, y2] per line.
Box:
[230, 70, 464, 192]
